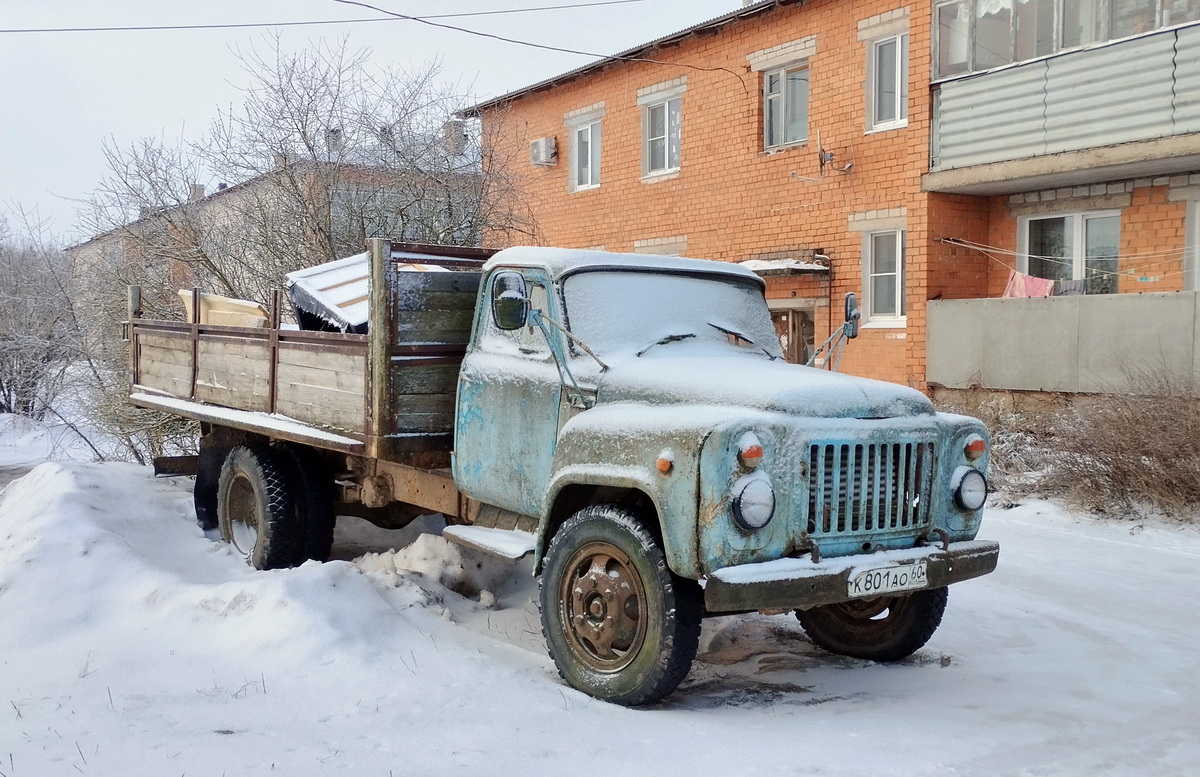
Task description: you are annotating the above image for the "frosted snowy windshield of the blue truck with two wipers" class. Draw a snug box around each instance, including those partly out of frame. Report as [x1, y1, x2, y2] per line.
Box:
[563, 271, 782, 359]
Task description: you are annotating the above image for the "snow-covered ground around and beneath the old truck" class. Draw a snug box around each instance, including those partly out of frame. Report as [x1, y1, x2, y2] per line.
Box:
[0, 419, 1200, 777]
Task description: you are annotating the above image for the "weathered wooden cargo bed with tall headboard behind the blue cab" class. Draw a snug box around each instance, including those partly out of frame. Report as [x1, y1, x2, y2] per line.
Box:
[130, 240, 492, 466]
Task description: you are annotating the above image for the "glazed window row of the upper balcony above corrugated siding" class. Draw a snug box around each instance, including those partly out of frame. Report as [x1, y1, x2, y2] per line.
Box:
[934, 0, 1200, 78]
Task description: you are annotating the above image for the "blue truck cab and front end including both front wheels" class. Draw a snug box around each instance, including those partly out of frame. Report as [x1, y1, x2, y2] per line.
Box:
[452, 247, 1000, 704]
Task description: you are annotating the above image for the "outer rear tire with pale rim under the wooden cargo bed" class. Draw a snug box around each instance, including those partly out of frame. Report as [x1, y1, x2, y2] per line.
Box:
[217, 445, 301, 570]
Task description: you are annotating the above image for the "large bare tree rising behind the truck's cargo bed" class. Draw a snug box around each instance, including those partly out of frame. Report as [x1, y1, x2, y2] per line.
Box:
[77, 37, 535, 302]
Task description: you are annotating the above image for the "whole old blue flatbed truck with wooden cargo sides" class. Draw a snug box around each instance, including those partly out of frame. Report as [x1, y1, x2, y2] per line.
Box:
[127, 240, 1000, 705]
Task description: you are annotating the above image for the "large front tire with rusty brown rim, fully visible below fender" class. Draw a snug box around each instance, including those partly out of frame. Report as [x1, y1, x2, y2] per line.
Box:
[540, 505, 703, 706]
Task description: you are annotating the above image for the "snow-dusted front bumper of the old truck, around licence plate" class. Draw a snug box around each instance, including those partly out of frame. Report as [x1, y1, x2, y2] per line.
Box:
[704, 541, 1000, 613]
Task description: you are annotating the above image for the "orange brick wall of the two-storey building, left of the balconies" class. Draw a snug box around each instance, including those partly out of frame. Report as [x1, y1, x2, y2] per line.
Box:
[482, 0, 930, 384]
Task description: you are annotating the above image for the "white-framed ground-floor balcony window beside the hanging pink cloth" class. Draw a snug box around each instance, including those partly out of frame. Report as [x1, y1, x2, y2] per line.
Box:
[1019, 211, 1121, 294]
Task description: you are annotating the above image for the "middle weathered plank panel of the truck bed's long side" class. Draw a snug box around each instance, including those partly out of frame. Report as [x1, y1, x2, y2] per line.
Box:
[196, 337, 271, 411]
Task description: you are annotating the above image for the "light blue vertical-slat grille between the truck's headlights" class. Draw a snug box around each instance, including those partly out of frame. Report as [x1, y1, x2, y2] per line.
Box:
[808, 441, 935, 536]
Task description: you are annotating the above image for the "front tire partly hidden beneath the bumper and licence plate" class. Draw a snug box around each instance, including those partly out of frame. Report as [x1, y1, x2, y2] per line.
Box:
[796, 588, 949, 662]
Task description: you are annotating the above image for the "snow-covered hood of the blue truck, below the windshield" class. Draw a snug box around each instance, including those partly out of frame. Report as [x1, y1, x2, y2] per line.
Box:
[596, 354, 934, 418]
